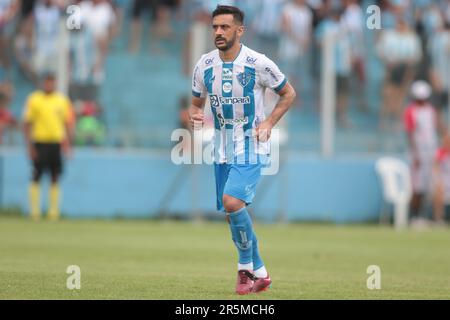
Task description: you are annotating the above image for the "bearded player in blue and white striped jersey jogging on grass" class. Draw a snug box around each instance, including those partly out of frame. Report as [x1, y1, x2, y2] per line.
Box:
[190, 5, 295, 294]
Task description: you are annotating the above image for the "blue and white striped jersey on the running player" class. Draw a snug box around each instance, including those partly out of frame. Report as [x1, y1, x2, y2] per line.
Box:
[192, 45, 286, 163]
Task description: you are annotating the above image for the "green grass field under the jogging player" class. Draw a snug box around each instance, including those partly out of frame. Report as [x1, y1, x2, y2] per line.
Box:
[0, 217, 450, 300]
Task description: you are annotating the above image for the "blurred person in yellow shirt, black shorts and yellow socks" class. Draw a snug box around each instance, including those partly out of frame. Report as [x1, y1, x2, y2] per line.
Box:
[24, 74, 72, 221]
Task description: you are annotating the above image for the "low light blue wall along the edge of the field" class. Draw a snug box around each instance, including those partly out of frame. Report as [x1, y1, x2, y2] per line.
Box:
[0, 149, 383, 223]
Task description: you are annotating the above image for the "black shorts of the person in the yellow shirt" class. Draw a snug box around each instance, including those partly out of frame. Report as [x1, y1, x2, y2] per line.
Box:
[33, 143, 63, 178]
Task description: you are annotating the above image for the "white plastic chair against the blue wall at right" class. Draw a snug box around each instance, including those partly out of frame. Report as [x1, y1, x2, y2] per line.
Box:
[375, 157, 412, 230]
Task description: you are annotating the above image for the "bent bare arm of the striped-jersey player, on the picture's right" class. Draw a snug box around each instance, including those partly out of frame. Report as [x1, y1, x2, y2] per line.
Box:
[256, 82, 296, 142]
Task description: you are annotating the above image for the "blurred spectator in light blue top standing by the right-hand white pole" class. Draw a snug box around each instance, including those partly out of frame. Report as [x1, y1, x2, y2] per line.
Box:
[316, 9, 352, 128]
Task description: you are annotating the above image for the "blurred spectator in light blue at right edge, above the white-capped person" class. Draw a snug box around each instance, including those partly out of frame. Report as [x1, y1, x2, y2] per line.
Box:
[428, 23, 450, 115]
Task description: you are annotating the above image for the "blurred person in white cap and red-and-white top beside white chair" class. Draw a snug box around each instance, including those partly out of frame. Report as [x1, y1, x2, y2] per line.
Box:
[404, 80, 444, 223]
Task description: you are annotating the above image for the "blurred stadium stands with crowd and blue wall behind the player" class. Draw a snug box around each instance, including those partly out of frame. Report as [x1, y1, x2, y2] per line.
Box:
[0, 0, 450, 223]
